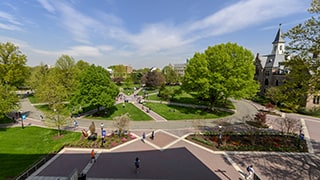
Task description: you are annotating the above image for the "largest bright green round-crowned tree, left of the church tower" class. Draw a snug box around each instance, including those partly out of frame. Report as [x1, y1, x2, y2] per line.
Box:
[183, 43, 259, 108]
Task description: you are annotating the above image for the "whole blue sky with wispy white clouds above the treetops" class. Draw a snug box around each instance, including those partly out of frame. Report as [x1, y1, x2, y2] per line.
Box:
[0, 0, 310, 69]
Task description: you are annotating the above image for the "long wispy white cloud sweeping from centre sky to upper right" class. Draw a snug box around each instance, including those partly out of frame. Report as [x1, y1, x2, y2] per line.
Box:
[100, 0, 305, 55]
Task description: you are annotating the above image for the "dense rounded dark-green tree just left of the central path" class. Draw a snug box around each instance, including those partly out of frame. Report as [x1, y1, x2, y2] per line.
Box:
[72, 65, 119, 111]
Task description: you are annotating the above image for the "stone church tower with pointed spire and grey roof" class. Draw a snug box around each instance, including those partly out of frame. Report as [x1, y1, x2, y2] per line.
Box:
[254, 24, 288, 95]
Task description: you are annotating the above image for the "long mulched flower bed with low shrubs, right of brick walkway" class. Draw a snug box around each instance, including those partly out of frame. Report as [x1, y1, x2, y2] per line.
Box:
[186, 134, 308, 152]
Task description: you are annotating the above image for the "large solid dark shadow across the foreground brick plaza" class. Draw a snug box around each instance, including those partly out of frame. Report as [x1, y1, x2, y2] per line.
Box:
[35, 148, 222, 180]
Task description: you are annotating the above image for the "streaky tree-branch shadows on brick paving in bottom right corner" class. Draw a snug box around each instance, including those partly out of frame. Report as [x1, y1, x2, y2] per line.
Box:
[229, 153, 320, 180]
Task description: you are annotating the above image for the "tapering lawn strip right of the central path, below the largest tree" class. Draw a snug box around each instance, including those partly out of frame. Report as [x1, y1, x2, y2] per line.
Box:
[145, 103, 231, 120]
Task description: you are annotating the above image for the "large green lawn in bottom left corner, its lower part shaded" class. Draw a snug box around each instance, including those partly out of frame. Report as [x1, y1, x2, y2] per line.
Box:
[0, 126, 81, 179]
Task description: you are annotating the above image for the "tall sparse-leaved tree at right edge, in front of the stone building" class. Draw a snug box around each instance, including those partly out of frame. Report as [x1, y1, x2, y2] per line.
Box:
[284, 0, 320, 107]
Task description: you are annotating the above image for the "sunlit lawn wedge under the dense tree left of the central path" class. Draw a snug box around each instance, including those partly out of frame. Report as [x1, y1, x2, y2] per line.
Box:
[88, 103, 152, 121]
